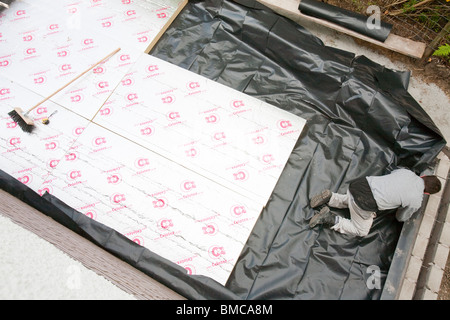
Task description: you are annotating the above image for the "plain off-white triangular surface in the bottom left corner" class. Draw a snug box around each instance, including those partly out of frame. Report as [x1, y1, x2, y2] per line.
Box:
[0, 215, 134, 300]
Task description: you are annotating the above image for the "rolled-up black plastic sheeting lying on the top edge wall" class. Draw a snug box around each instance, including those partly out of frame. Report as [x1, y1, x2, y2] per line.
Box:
[298, 0, 392, 42]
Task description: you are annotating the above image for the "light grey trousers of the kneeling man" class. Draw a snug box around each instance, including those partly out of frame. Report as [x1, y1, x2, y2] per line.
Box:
[328, 191, 376, 237]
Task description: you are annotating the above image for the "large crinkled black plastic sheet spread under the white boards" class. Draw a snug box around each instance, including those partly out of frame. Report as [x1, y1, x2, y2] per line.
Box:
[0, 0, 446, 299]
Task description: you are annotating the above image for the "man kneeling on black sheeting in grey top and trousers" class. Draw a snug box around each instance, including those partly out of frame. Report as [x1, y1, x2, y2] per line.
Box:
[309, 169, 441, 237]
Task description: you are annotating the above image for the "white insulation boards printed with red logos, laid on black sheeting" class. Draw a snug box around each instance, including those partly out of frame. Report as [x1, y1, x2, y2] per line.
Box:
[0, 0, 305, 284]
